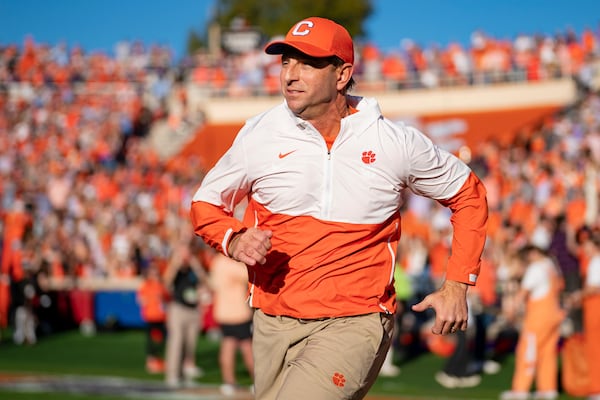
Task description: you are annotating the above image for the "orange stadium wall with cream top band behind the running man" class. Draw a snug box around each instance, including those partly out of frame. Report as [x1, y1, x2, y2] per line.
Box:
[172, 79, 576, 169]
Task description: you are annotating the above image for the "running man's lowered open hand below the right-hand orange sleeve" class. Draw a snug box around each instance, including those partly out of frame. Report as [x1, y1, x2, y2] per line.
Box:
[412, 281, 468, 335]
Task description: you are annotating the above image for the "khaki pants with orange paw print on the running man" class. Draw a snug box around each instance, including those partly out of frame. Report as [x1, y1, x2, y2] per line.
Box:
[252, 310, 394, 400]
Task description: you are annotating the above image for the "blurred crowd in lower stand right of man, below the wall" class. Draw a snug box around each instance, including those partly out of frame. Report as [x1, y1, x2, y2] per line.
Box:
[398, 92, 600, 387]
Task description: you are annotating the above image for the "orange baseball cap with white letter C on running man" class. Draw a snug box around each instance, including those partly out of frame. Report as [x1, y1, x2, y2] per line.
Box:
[265, 17, 354, 64]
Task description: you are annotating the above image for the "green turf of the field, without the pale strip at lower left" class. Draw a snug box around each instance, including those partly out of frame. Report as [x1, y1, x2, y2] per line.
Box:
[0, 330, 584, 400]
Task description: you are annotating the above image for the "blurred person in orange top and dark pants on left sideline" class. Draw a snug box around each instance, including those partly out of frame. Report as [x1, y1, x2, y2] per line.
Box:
[136, 263, 169, 374]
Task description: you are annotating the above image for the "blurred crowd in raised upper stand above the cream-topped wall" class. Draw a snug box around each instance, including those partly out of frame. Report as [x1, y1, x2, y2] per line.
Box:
[191, 24, 600, 96]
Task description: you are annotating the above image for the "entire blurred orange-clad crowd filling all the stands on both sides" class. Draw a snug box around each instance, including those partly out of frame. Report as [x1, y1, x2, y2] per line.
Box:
[0, 23, 600, 396]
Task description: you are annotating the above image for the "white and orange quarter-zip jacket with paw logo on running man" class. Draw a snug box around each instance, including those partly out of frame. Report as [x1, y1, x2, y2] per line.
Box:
[191, 96, 487, 319]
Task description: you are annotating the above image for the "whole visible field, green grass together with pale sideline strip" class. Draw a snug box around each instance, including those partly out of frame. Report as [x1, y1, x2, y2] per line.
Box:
[0, 330, 574, 400]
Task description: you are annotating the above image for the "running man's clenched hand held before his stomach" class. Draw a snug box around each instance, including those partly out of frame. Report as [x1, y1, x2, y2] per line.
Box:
[227, 228, 273, 265]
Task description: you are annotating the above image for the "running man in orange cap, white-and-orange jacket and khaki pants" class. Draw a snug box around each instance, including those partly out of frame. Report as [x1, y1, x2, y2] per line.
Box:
[191, 17, 487, 400]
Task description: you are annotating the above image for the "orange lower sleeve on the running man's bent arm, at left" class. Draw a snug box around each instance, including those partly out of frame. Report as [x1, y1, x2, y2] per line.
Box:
[191, 201, 246, 257]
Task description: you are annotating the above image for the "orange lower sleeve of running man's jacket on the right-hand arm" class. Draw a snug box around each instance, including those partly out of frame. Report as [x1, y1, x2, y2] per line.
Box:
[439, 172, 488, 285]
